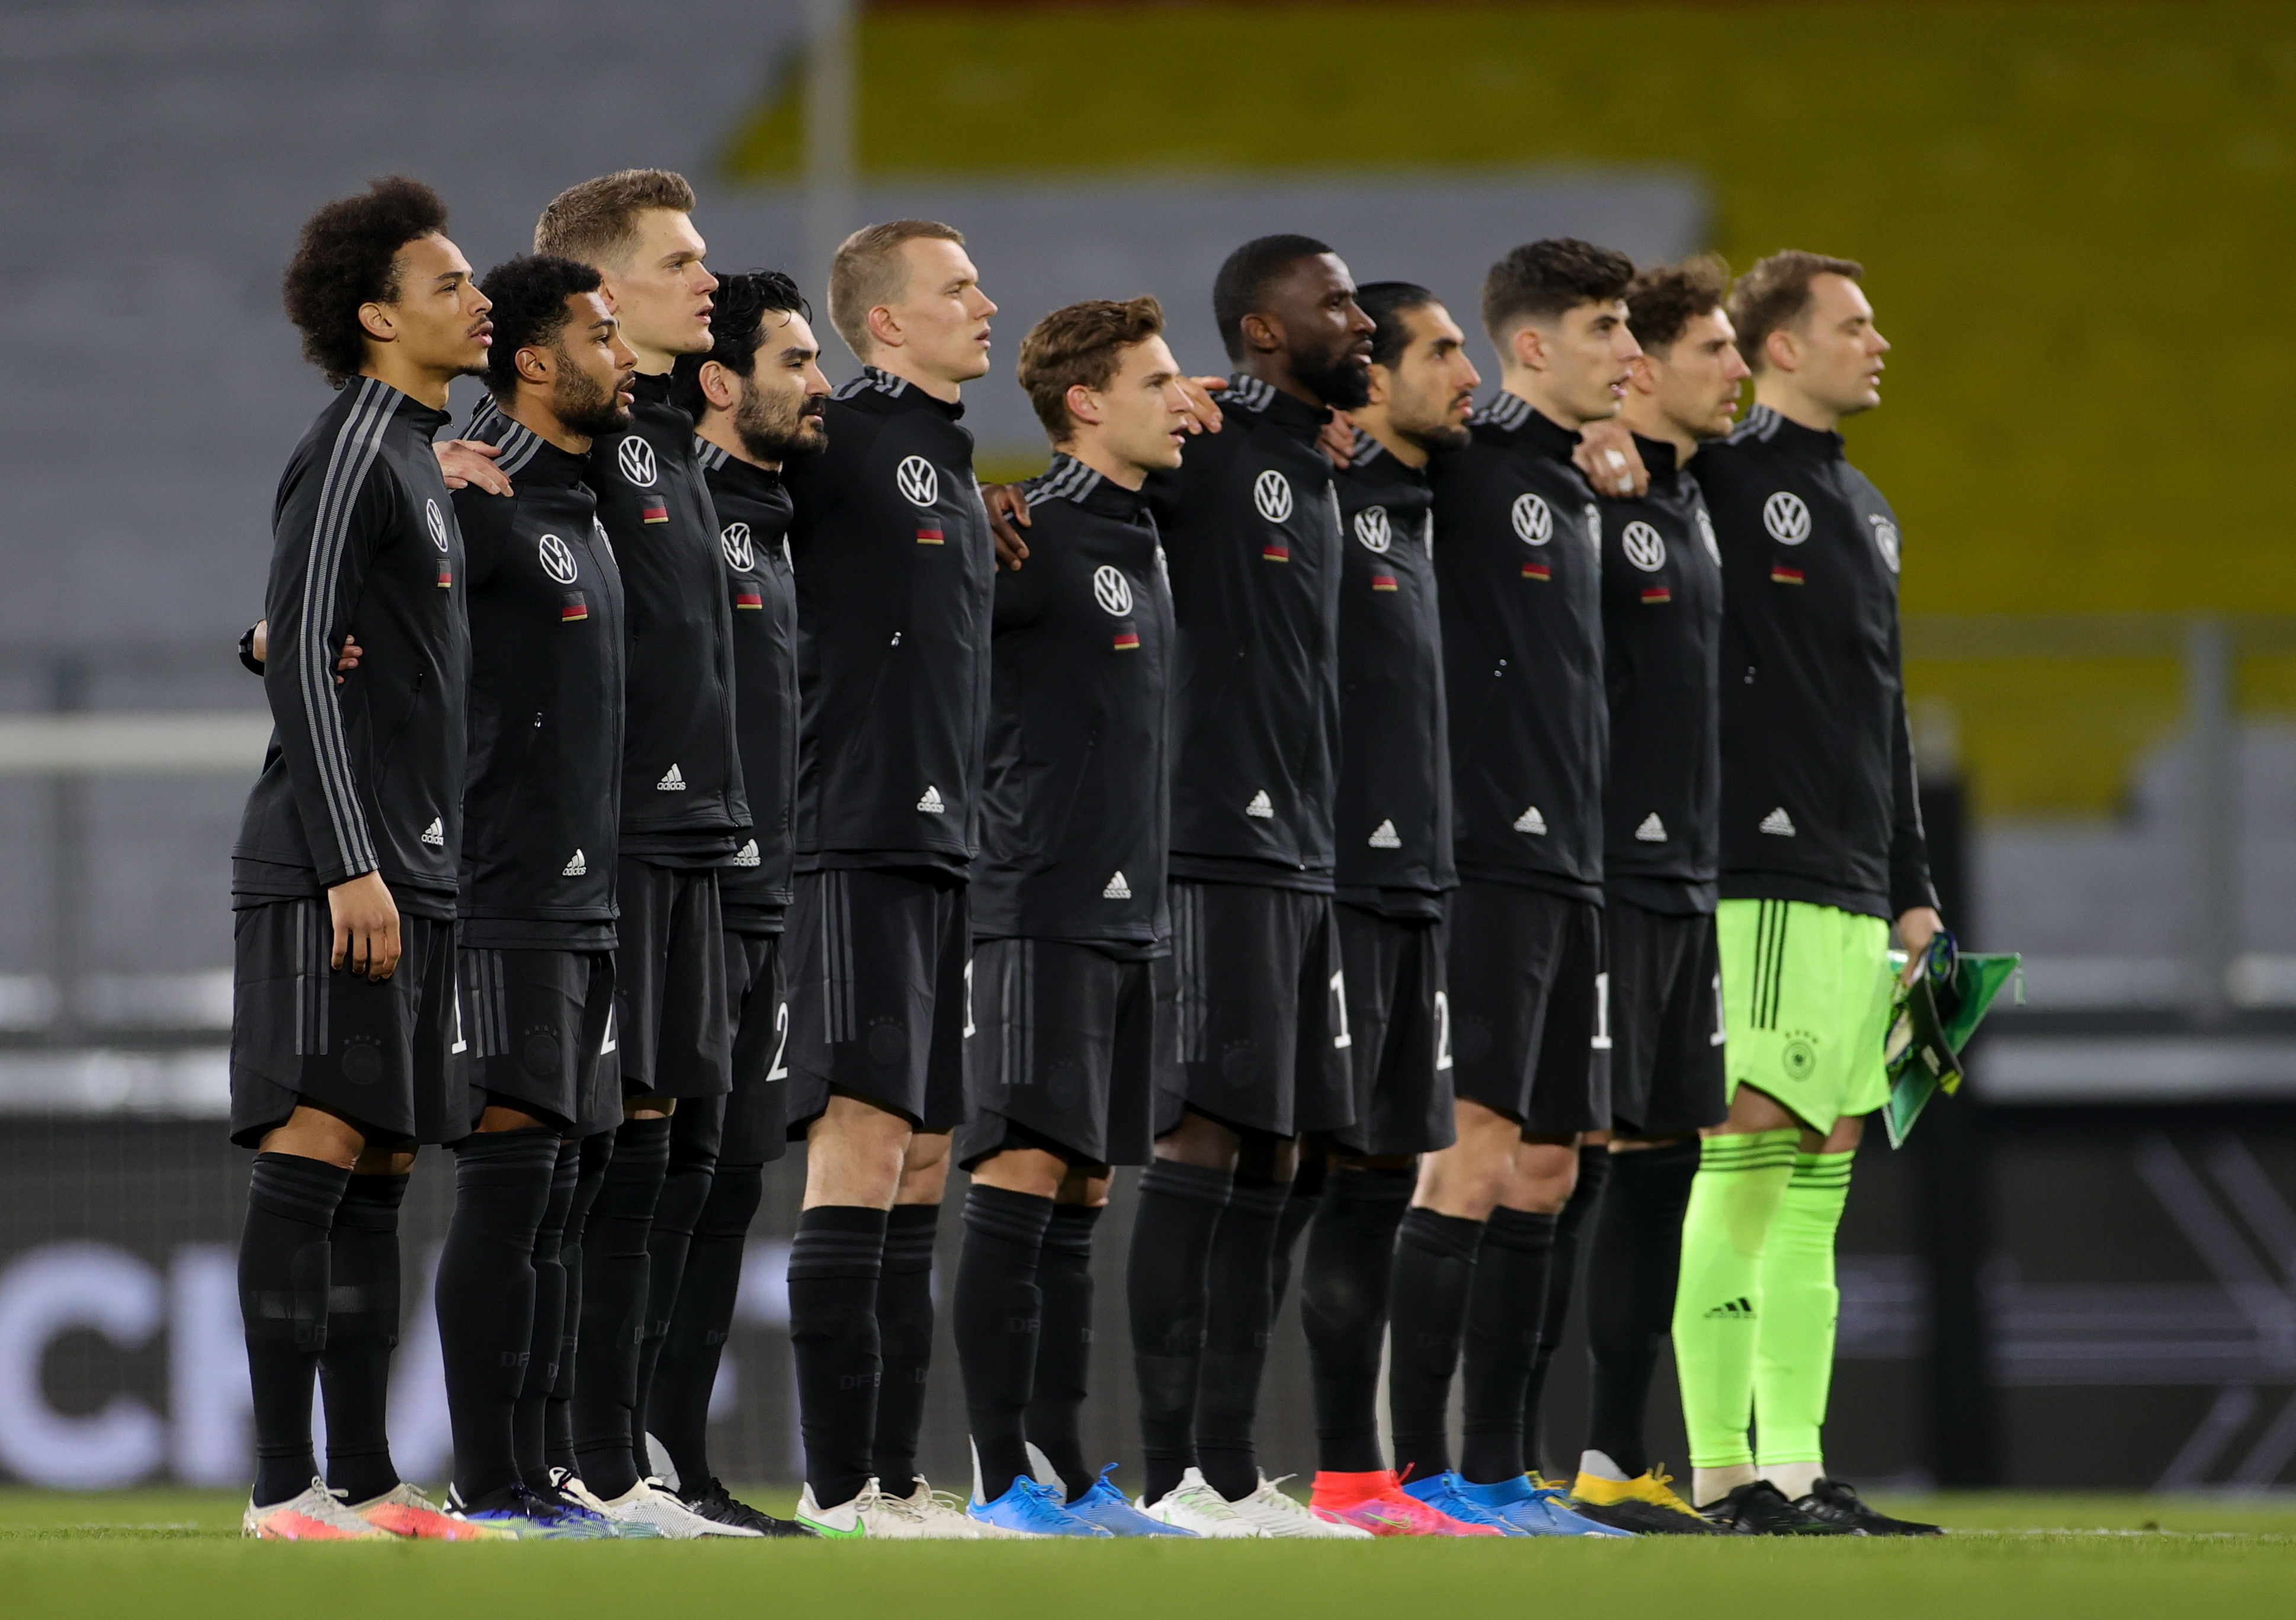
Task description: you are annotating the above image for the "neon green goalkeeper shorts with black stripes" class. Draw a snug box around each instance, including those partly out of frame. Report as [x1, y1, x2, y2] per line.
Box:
[1715, 900, 1890, 1131]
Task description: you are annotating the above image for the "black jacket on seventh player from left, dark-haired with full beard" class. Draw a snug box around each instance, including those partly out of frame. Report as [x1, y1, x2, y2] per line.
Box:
[1146, 376, 1341, 895]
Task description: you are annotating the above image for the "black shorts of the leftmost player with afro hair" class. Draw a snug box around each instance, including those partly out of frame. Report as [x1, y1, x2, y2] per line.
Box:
[232, 900, 475, 1152]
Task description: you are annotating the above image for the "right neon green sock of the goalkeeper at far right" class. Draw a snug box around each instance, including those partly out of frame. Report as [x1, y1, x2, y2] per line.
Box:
[1754, 1154, 1855, 1473]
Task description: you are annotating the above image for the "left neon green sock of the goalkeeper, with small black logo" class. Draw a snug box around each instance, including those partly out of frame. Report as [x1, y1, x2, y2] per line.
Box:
[1674, 1129, 1803, 1468]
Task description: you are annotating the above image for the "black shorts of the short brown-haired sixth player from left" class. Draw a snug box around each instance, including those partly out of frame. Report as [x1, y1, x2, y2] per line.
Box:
[955, 938, 1171, 1170]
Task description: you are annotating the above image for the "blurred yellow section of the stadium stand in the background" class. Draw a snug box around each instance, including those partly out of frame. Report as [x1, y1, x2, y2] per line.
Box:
[726, 0, 2296, 812]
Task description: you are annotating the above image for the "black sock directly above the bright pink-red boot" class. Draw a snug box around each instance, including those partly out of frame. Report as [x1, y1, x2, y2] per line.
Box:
[1313, 1166, 1419, 1473]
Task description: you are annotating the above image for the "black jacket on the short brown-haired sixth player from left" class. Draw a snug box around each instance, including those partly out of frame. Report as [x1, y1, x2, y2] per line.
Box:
[971, 454, 1173, 959]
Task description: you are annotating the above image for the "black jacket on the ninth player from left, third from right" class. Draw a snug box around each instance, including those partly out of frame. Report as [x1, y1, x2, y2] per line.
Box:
[1431, 394, 1609, 904]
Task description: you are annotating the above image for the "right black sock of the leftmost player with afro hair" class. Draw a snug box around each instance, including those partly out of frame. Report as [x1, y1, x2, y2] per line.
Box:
[319, 1175, 406, 1503]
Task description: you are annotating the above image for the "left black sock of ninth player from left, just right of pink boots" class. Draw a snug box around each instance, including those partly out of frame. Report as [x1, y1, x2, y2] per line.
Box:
[1387, 1210, 1487, 1480]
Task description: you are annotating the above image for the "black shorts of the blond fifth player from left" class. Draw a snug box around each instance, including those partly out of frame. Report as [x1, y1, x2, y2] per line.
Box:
[785, 870, 973, 1138]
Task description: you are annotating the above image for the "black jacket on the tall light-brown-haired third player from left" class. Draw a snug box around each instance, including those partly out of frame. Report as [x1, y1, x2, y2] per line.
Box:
[585, 374, 749, 867]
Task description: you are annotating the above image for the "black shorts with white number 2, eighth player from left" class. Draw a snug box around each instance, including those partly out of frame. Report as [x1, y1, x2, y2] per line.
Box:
[1332, 902, 1458, 1154]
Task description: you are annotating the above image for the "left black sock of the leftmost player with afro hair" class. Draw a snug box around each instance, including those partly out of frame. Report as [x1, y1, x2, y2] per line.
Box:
[239, 1154, 351, 1507]
